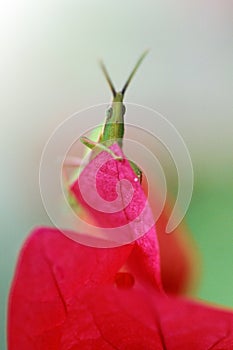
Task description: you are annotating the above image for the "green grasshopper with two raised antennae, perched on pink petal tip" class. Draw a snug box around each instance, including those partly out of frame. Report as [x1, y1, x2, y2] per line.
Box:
[80, 50, 148, 182]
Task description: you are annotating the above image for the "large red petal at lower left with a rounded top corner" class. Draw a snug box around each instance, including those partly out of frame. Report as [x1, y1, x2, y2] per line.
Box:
[9, 228, 132, 350]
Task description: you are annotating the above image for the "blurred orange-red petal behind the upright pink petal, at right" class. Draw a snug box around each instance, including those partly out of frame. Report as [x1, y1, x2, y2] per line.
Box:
[156, 198, 200, 294]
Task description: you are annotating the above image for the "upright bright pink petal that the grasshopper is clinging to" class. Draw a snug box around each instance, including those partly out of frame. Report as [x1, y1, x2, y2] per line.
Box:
[71, 144, 161, 289]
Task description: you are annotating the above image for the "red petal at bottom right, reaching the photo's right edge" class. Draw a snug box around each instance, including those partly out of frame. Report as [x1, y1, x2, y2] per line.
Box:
[84, 288, 233, 350]
